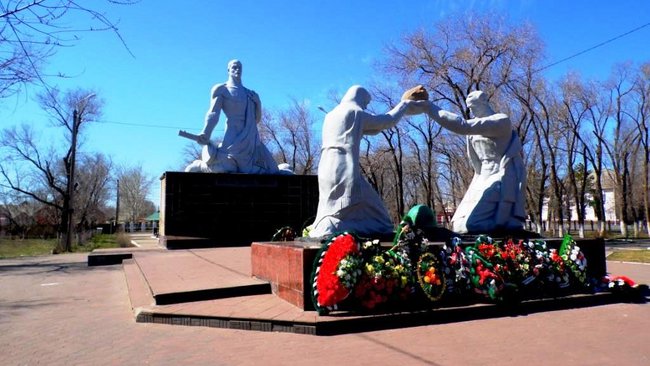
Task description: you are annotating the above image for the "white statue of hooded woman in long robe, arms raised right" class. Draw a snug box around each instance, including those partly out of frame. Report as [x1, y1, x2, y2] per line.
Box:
[309, 85, 413, 238]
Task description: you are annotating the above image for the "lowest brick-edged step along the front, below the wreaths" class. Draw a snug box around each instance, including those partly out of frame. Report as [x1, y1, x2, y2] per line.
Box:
[136, 293, 625, 335]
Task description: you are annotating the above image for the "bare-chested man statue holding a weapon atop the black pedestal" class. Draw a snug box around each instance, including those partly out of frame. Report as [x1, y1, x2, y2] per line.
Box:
[179, 60, 287, 174]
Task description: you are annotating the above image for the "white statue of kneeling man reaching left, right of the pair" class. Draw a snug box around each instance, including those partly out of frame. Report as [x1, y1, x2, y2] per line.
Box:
[418, 91, 526, 234]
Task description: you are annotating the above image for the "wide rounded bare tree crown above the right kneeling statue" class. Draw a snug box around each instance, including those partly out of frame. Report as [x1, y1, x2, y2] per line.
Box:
[383, 14, 541, 114]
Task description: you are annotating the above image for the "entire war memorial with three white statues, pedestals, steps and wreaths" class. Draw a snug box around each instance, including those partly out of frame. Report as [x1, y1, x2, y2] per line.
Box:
[89, 60, 638, 334]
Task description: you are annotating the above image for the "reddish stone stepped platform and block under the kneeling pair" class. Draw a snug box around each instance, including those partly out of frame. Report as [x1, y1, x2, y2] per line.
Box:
[100, 236, 645, 335]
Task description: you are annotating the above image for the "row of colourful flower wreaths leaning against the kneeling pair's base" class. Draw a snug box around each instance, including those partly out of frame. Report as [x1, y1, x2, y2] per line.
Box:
[312, 226, 636, 314]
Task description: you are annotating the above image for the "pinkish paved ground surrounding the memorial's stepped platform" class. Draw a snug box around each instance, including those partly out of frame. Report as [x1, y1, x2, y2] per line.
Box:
[0, 254, 650, 366]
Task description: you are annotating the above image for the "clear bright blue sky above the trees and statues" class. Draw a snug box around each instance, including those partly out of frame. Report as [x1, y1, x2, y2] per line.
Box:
[0, 0, 650, 204]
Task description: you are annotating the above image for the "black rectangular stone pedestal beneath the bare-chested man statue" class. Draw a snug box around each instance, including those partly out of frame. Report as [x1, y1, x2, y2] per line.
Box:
[159, 172, 318, 249]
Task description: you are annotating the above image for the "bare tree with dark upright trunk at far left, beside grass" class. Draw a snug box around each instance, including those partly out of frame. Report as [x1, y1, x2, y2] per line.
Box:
[0, 89, 102, 252]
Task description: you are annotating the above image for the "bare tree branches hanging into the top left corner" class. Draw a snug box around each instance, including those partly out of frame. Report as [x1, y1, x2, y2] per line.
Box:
[0, 0, 139, 98]
